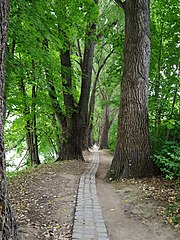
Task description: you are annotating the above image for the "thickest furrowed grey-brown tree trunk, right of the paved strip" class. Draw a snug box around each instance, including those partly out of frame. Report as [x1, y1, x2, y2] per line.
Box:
[108, 0, 153, 179]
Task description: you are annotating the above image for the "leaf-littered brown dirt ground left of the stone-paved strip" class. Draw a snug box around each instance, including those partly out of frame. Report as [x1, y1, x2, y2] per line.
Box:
[9, 158, 88, 240]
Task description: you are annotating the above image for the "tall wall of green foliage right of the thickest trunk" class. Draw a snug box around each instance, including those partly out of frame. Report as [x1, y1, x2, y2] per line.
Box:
[149, 0, 180, 179]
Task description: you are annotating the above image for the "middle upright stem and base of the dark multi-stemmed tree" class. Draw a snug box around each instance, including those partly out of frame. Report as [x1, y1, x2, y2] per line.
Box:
[58, 45, 83, 160]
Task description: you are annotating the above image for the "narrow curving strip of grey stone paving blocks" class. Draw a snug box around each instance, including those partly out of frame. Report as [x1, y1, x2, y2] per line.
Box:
[72, 146, 109, 240]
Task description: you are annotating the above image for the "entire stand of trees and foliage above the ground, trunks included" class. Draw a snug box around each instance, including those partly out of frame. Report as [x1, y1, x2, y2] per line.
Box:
[0, 0, 180, 239]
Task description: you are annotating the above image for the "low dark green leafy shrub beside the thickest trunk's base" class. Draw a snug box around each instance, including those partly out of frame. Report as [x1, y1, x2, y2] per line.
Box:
[154, 142, 180, 180]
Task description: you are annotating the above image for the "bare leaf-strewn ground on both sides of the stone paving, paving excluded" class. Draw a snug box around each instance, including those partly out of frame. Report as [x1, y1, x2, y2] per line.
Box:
[9, 150, 180, 240]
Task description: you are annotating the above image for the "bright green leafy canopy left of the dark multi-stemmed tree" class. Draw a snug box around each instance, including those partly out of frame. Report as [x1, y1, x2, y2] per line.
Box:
[5, 0, 98, 167]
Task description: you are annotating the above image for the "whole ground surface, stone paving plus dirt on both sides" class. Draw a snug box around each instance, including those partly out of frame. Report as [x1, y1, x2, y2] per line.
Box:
[9, 147, 180, 240]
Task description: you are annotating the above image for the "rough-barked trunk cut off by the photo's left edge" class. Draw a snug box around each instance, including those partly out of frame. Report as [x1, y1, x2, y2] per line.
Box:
[0, 0, 18, 240]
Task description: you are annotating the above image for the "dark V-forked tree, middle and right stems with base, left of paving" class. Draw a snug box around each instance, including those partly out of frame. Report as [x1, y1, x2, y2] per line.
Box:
[56, 0, 98, 160]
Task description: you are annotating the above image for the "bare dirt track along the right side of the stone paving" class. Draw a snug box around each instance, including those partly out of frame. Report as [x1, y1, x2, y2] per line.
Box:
[97, 150, 180, 240]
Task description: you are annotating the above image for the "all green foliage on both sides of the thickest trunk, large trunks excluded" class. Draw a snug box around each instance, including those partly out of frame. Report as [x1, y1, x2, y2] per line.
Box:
[5, 0, 180, 178]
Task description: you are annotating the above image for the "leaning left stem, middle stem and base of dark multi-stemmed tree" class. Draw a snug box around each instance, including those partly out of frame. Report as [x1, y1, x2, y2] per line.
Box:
[43, 37, 83, 161]
